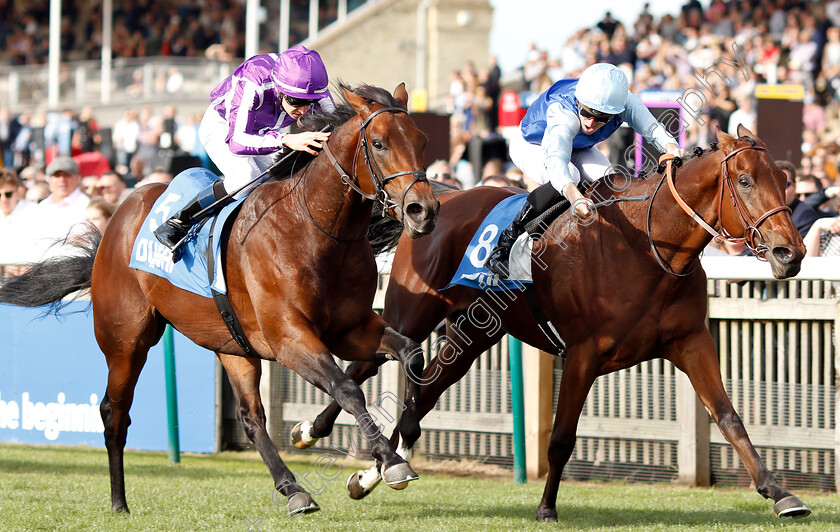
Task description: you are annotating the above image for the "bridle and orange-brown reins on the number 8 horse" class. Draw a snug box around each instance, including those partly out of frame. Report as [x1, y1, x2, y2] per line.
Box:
[647, 142, 791, 277]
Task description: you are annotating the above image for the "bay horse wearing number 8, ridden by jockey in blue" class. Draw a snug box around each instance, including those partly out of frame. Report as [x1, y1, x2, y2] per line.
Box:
[297, 127, 810, 521]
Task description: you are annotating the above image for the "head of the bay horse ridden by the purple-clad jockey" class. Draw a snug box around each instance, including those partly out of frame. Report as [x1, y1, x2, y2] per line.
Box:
[341, 83, 440, 238]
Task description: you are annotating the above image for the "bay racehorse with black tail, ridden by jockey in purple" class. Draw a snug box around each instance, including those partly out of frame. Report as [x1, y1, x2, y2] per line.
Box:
[0, 84, 439, 514]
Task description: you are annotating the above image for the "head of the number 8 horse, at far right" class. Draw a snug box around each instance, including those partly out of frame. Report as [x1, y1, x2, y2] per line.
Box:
[717, 125, 805, 279]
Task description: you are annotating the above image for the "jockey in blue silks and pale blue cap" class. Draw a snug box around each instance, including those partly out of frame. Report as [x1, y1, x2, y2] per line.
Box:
[485, 63, 685, 278]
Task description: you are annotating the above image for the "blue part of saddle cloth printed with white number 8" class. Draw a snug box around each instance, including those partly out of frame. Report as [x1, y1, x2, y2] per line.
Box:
[444, 194, 533, 291]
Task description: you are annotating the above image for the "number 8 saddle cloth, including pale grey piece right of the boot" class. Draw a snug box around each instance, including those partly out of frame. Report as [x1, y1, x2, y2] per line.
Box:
[443, 194, 533, 291]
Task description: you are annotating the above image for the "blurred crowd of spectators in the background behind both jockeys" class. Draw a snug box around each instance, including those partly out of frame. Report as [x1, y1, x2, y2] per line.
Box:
[0, 0, 840, 266]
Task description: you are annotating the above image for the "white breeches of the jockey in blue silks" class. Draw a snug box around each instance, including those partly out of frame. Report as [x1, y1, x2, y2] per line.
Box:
[510, 128, 615, 193]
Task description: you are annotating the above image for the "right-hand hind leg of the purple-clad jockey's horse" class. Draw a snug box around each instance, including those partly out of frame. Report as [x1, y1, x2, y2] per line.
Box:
[216, 353, 321, 515]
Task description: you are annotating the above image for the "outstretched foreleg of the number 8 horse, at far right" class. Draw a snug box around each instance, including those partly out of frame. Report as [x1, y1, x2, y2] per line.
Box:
[665, 328, 811, 517]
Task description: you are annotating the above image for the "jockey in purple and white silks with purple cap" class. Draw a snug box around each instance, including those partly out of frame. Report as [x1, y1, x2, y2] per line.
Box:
[154, 45, 335, 260]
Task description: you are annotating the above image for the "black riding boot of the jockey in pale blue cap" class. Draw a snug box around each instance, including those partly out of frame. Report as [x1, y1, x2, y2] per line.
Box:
[484, 183, 568, 279]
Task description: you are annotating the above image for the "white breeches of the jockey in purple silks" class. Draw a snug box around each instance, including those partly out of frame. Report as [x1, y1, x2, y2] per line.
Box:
[198, 105, 274, 199]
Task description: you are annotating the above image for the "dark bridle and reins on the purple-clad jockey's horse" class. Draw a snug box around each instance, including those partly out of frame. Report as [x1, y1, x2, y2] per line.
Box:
[324, 107, 428, 218]
